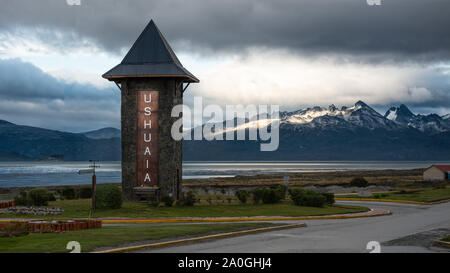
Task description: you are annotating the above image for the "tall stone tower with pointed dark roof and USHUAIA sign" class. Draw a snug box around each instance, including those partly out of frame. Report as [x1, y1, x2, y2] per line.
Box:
[103, 20, 199, 200]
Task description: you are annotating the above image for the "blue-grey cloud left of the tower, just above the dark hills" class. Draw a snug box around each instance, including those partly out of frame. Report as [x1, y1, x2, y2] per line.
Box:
[0, 59, 120, 132]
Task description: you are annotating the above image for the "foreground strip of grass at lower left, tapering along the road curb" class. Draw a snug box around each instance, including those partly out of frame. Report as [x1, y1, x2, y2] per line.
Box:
[0, 223, 275, 253]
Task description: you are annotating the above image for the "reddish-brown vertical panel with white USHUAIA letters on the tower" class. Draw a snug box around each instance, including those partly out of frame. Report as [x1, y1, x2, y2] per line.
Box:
[136, 91, 159, 187]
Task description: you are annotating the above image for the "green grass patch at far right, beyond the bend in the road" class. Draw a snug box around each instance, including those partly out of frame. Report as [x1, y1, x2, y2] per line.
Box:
[336, 188, 450, 202]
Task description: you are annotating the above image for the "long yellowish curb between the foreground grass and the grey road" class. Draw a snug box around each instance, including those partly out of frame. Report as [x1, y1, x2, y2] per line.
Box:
[93, 223, 306, 253]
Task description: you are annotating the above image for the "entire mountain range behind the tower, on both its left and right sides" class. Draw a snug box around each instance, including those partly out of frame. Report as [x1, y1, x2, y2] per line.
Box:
[0, 101, 450, 161]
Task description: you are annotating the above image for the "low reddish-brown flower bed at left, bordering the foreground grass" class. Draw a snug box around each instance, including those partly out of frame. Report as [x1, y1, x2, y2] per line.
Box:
[27, 220, 102, 233]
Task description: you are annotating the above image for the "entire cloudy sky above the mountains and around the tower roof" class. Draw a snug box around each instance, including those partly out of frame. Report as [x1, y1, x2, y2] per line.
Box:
[0, 0, 450, 132]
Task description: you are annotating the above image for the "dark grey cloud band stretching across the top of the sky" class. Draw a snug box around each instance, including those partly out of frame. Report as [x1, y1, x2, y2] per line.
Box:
[0, 0, 450, 61]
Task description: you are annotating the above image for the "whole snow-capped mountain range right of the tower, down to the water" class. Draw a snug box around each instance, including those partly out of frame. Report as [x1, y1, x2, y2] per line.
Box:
[183, 101, 450, 161]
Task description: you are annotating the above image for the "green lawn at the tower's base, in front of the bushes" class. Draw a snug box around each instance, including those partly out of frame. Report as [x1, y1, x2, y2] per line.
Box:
[0, 199, 369, 218]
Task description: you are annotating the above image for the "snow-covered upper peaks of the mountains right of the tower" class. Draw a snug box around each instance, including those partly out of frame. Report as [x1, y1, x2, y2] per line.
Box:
[214, 101, 450, 135]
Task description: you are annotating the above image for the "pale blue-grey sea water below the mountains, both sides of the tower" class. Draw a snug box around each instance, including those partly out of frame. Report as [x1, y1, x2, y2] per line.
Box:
[0, 161, 449, 187]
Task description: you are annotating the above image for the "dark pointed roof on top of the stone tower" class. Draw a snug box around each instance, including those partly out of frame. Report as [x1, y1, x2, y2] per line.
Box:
[102, 20, 199, 82]
